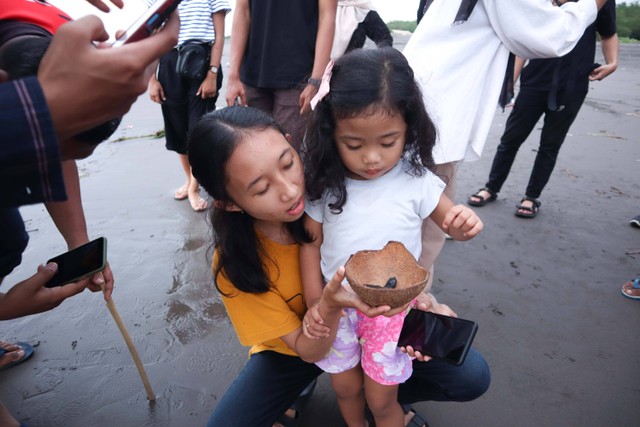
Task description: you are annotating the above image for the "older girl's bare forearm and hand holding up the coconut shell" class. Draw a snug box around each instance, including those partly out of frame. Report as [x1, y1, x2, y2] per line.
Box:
[281, 267, 390, 363]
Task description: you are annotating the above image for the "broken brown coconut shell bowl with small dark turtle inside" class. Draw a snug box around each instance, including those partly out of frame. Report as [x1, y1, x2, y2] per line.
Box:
[345, 241, 429, 308]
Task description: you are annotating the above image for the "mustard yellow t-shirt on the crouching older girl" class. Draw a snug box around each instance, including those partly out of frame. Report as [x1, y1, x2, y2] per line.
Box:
[214, 236, 306, 356]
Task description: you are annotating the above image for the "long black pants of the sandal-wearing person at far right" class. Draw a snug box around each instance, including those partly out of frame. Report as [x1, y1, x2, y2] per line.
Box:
[486, 79, 589, 199]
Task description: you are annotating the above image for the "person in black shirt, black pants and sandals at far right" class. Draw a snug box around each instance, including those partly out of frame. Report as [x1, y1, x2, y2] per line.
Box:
[467, 0, 619, 218]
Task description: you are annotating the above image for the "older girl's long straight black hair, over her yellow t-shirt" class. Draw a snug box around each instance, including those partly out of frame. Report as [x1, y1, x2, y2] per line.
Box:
[189, 106, 309, 296]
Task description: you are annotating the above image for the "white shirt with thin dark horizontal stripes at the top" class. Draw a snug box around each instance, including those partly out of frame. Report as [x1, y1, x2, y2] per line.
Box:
[178, 0, 231, 45]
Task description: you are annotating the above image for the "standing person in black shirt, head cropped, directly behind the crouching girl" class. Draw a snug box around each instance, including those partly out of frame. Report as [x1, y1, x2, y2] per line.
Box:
[226, 0, 337, 148]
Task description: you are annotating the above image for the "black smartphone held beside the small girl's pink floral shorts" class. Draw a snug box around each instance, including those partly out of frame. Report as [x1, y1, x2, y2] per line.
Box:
[398, 310, 478, 366]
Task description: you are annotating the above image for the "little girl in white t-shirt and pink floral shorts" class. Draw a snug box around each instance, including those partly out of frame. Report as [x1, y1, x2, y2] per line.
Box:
[300, 48, 482, 427]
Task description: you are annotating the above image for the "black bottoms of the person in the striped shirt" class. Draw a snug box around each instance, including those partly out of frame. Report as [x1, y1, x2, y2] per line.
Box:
[158, 49, 222, 154]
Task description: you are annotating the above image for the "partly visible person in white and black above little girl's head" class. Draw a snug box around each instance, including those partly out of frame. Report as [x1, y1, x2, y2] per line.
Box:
[331, 0, 393, 59]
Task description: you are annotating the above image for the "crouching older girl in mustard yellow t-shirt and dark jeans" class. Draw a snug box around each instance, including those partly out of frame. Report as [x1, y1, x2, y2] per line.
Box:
[189, 107, 489, 427]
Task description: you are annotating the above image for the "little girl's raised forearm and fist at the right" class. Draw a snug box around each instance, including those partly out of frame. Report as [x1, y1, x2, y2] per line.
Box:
[429, 193, 483, 240]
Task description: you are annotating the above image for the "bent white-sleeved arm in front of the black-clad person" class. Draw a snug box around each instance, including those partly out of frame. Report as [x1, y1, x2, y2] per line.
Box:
[483, 0, 606, 59]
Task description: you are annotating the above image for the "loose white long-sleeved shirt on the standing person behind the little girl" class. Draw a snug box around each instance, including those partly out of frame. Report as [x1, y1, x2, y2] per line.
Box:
[403, 0, 598, 164]
